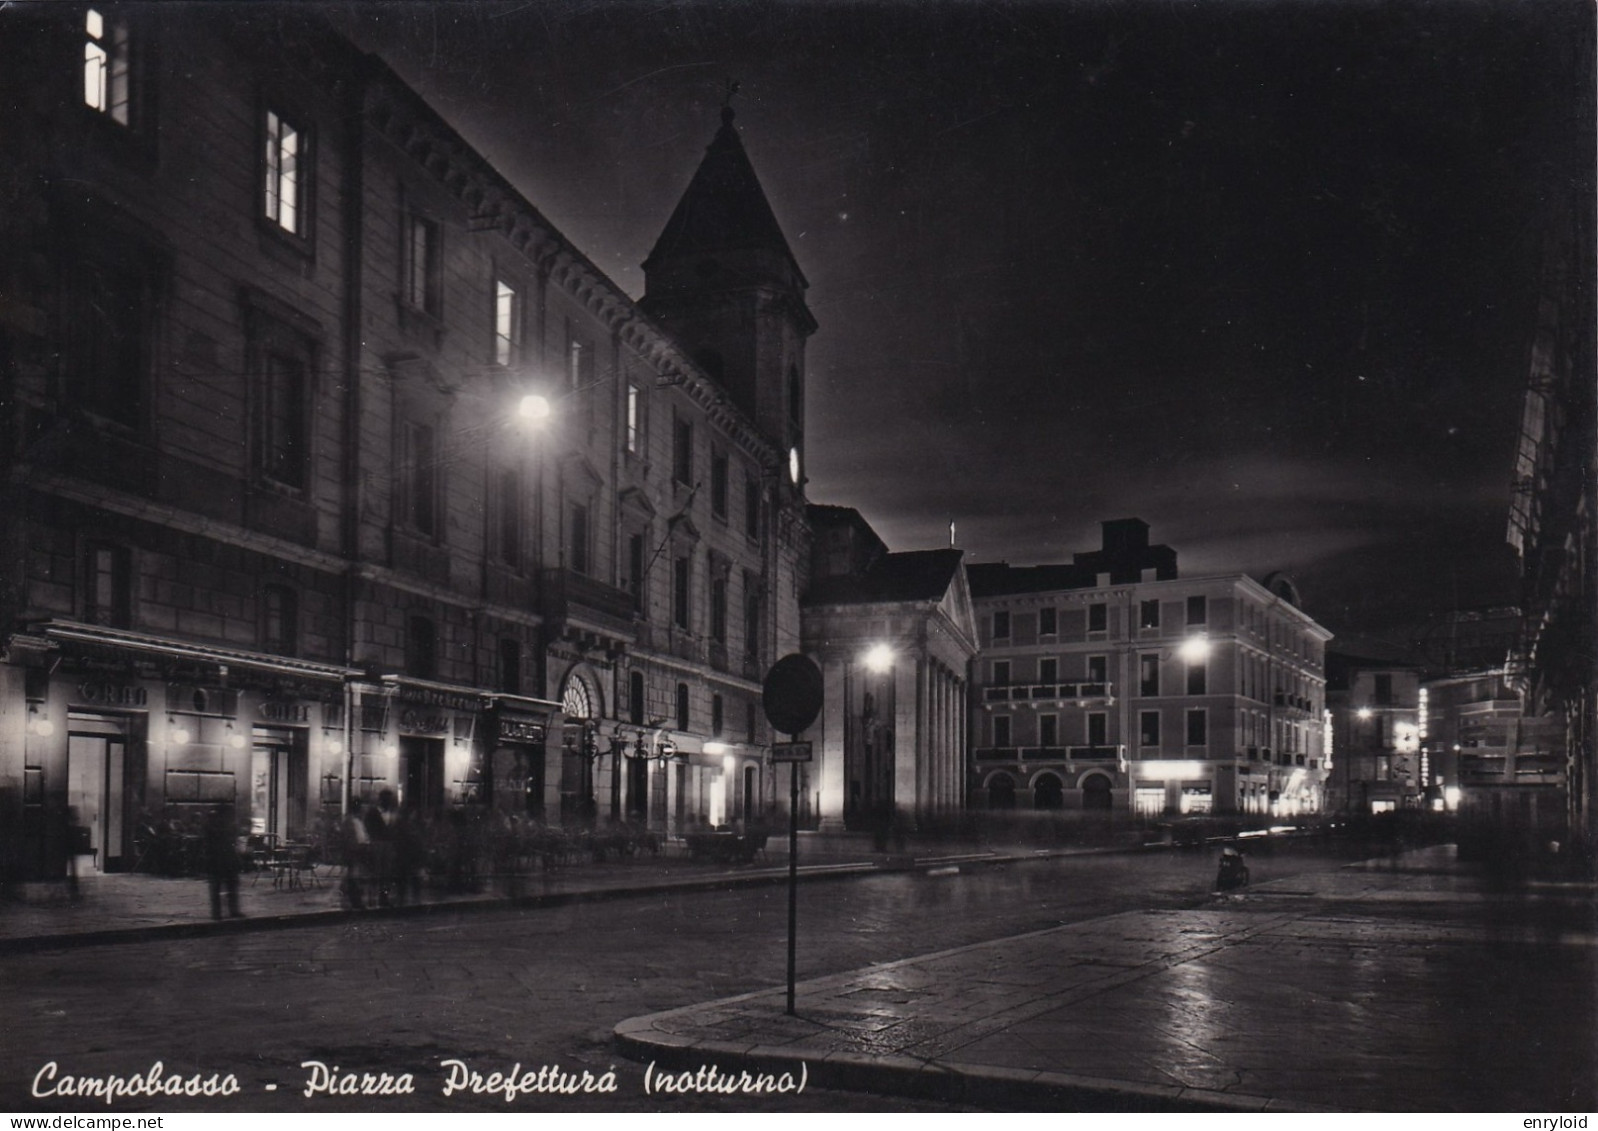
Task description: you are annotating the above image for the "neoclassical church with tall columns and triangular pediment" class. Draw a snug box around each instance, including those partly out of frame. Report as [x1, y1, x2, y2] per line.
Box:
[802, 506, 976, 829]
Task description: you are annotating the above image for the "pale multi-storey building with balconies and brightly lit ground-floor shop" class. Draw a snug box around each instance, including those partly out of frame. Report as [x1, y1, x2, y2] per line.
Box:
[967, 519, 1331, 816]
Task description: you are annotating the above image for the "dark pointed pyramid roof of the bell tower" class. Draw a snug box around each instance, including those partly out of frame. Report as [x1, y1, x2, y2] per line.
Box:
[644, 105, 809, 289]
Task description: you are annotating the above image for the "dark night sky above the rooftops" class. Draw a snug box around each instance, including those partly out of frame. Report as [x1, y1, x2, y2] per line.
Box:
[324, 0, 1593, 636]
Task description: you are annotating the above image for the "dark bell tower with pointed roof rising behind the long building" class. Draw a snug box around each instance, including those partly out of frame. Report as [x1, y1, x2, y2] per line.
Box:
[639, 105, 817, 489]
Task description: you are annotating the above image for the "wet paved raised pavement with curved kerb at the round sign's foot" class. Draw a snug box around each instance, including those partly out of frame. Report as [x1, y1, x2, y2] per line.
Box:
[615, 848, 1598, 1112]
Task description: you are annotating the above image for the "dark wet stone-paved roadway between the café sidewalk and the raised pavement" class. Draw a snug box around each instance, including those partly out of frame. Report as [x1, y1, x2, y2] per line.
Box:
[0, 845, 1374, 1112]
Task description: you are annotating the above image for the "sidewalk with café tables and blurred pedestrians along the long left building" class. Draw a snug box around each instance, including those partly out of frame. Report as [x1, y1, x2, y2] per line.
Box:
[0, 834, 1093, 955]
